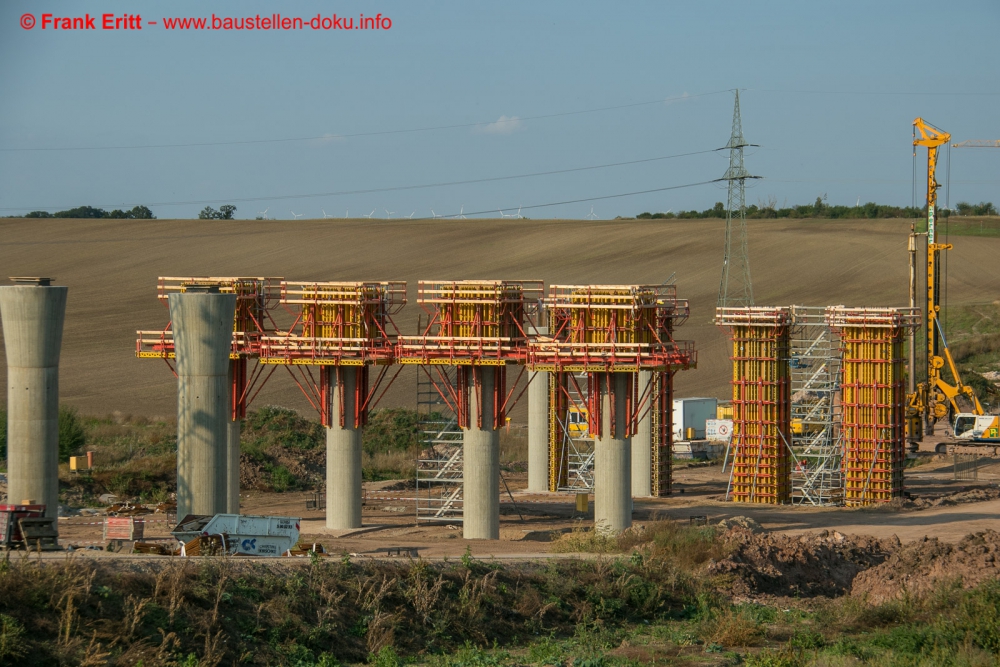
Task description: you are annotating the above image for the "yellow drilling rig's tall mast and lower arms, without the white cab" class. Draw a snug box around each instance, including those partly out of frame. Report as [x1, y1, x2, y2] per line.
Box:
[906, 118, 983, 442]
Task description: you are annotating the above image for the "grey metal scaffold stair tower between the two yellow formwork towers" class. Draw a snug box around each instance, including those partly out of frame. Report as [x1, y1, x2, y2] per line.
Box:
[788, 306, 844, 505]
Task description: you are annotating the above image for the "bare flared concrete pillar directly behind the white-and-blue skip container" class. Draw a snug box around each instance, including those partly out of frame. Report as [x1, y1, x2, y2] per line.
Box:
[168, 287, 236, 519]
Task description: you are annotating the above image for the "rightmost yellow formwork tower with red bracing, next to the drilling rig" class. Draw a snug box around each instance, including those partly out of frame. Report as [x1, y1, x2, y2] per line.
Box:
[827, 306, 920, 506]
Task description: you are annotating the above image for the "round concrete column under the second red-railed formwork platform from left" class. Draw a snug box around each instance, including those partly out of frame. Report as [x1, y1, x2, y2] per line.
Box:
[324, 366, 362, 529]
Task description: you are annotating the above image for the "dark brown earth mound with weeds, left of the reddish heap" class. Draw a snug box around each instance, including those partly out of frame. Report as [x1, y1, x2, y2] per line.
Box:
[708, 526, 900, 597]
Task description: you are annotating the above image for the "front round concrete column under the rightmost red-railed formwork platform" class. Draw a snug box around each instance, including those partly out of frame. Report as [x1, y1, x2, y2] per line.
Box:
[594, 373, 632, 534]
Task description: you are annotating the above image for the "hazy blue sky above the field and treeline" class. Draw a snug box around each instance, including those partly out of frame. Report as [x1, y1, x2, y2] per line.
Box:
[0, 0, 1000, 218]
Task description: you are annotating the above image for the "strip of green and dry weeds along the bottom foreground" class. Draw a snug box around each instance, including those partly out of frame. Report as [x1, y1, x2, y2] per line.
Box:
[0, 522, 1000, 667]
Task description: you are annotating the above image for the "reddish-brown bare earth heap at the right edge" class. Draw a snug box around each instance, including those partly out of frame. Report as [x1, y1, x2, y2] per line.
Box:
[851, 530, 1000, 604]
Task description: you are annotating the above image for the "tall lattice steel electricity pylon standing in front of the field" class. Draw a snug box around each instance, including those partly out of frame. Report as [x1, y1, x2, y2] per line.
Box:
[717, 89, 760, 308]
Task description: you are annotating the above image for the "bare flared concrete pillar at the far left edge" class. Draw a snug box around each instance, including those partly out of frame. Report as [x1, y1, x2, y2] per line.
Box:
[0, 278, 68, 518]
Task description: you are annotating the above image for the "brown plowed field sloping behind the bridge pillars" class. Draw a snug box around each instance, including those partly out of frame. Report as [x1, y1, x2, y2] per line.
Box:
[0, 219, 1000, 420]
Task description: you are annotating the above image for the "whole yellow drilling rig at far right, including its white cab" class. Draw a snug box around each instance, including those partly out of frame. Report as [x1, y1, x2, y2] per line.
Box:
[906, 118, 984, 449]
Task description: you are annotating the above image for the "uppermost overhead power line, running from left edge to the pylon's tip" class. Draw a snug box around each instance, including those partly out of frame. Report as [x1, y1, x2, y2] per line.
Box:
[0, 90, 728, 152]
